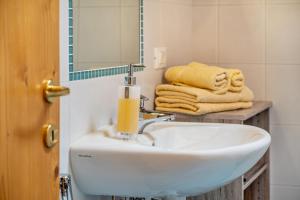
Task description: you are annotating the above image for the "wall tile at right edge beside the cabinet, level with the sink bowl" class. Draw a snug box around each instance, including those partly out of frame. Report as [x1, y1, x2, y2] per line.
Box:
[271, 125, 300, 186]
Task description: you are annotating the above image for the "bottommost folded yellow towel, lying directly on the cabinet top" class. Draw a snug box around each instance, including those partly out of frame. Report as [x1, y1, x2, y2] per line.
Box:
[155, 100, 253, 115]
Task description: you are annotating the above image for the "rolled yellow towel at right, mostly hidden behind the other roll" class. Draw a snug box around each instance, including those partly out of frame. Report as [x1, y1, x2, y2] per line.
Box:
[227, 69, 245, 92]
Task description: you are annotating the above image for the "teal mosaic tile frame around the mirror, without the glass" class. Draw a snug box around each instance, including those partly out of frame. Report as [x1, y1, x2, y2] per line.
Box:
[68, 0, 144, 81]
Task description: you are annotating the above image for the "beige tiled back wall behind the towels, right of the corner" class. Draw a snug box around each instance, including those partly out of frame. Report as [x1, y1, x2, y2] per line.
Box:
[192, 0, 300, 200]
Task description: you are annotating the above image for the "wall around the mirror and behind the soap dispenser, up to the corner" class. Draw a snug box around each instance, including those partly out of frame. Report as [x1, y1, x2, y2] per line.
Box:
[60, 0, 192, 200]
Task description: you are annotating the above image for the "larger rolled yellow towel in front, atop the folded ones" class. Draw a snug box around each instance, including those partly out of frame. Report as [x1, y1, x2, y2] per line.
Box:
[165, 63, 229, 94]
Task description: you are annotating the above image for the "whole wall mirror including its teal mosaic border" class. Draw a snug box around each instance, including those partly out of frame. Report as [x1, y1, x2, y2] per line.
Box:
[69, 0, 144, 80]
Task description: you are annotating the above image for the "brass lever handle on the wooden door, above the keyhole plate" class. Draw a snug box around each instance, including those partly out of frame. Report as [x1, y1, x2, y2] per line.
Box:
[43, 80, 70, 103]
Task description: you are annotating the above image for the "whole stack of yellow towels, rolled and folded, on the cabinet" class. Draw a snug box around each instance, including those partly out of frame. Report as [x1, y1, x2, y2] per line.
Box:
[155, 62, 254, 115]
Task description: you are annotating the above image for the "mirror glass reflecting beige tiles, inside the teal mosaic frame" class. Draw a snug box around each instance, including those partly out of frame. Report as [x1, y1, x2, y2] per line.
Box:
[73, 0, 139, 70]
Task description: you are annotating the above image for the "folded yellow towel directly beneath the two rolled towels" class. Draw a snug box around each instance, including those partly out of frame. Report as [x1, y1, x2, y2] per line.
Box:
[156, 84, 254, 103]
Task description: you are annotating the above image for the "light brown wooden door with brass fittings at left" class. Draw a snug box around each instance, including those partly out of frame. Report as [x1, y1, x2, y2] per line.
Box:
[0, 0, 59, 200]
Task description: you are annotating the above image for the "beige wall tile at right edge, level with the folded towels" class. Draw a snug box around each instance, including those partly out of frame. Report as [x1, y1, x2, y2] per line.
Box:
[266, 65, 300, 124]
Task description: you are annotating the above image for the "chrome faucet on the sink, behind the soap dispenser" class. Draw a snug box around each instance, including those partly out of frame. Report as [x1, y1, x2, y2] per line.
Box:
[138, 95, 175, 134]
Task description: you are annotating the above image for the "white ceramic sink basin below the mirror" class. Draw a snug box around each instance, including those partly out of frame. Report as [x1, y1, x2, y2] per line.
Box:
[70, 122, 271, 197]
